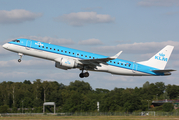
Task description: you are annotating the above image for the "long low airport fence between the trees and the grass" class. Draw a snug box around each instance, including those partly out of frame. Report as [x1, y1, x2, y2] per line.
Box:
[0, 111, 179, 116]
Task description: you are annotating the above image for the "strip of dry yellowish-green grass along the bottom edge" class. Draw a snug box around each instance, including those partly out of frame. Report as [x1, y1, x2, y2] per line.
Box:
[0, 115, 179, 120]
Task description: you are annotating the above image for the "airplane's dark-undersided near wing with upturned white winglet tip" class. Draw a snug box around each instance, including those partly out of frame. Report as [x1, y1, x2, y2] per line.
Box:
[79, 51, 122, 66]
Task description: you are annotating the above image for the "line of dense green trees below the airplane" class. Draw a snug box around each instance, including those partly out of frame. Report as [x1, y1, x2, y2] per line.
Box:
[0, 79, 179, 112]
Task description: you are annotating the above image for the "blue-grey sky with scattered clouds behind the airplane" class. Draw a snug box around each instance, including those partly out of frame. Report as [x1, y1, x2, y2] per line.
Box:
[0, 0, 179, 90]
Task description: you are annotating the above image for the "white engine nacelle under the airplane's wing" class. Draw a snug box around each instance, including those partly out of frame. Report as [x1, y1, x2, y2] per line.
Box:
[55, 58, 78, 70]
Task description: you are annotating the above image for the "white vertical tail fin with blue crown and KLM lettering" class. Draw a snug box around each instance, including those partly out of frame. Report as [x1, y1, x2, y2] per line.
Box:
[138, 45, 174, 70]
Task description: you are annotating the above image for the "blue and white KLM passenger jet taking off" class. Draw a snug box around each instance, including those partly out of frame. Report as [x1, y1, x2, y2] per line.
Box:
[3, 38, 175, 78]
